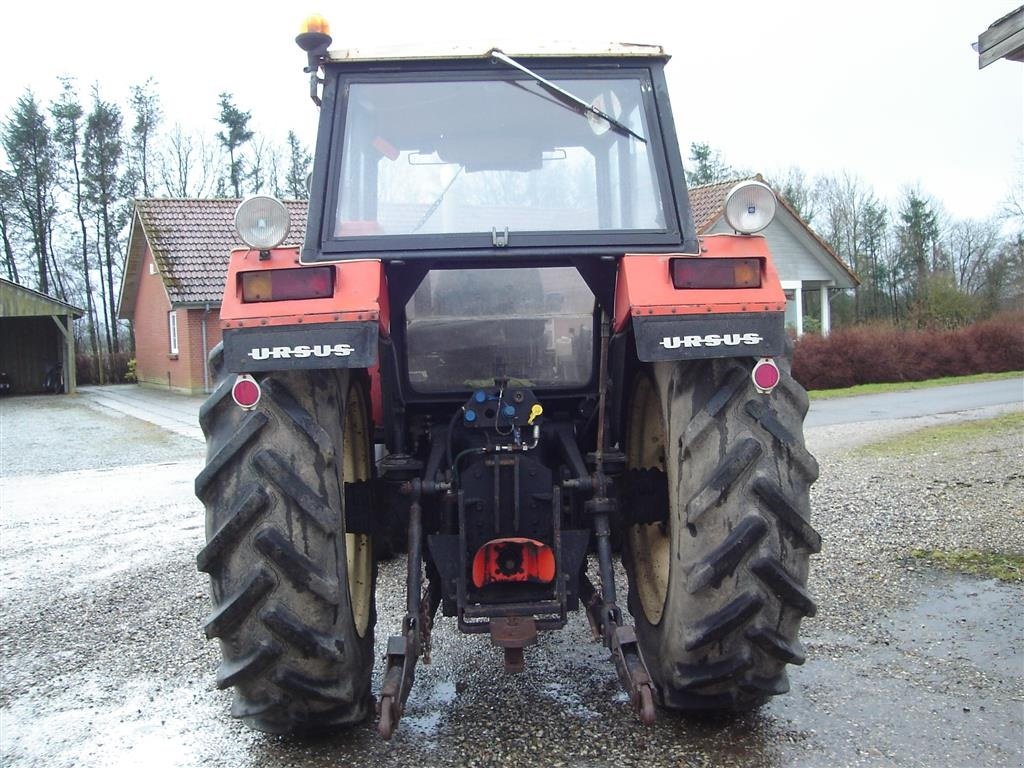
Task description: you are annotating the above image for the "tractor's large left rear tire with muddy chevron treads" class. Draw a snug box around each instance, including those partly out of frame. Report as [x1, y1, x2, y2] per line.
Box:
[196, 355, 376, 733]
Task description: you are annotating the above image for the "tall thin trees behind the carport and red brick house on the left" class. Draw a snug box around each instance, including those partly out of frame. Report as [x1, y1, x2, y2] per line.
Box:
[0, 78, 310, 382]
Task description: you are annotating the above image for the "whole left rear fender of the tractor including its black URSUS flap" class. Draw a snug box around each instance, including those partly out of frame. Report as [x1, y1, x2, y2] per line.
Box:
[220, 248, 390, 373]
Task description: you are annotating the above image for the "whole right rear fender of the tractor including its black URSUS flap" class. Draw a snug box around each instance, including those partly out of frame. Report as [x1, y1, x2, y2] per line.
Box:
[614, 234, 785, 362]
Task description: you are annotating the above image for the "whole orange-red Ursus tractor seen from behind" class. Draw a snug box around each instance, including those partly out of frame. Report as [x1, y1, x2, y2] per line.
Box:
[196, 17, 820, 737]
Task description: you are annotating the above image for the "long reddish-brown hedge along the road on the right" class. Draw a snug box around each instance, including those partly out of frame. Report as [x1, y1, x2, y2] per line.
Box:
[793, 312, 1024, 389]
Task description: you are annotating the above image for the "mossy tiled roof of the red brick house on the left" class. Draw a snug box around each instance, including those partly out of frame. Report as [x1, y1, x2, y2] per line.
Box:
[119, 198, 308, 318]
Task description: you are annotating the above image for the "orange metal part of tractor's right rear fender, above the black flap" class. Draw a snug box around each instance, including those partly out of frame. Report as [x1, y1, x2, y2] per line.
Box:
[614, 234, 785, 332]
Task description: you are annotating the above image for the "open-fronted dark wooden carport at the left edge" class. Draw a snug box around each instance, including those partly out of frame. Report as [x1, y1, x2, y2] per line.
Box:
[0, 278, 85, 394]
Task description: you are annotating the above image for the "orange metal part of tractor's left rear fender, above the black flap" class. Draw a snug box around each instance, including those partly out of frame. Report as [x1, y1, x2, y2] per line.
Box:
[220, 248, 390, 336]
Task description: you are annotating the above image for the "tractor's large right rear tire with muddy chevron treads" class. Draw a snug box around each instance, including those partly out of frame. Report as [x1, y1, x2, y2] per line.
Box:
[624, 359, 821, 711]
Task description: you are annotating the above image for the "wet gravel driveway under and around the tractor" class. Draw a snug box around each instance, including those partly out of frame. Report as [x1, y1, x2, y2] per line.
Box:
[0, 397, 1024, 768]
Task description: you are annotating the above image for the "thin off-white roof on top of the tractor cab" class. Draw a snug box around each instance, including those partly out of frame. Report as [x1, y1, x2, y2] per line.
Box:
[327, 42, 670, 62]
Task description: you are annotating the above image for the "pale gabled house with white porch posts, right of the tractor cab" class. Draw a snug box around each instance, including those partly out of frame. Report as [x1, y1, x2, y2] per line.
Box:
[690, 182, 860, 336]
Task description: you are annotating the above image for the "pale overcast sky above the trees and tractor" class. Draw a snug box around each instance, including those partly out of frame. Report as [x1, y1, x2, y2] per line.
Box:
[0, 0, 1024, 222]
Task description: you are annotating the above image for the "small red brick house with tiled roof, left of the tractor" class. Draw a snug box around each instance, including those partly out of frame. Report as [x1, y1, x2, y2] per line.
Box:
[118, 199, 306, 393]
